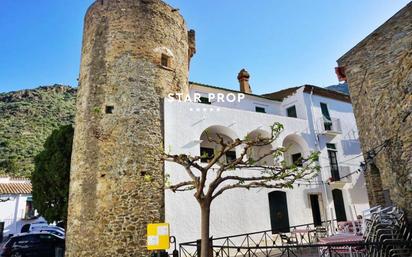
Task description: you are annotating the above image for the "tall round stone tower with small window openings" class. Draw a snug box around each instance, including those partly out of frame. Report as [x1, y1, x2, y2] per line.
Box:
[66, 0, 195, 257]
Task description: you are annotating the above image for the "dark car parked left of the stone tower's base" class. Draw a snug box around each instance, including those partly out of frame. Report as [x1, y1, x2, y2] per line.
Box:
[0, 232, 64, 257]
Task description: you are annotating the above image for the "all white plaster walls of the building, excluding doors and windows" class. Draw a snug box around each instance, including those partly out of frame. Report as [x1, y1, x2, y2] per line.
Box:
[164, 87, 369, 243]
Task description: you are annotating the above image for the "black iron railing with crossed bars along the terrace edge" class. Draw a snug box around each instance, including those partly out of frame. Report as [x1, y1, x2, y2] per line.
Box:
[179, 218, 412, 257]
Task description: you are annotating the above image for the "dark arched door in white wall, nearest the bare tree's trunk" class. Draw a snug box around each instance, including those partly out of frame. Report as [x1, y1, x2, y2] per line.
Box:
[269, 191, 290, 233]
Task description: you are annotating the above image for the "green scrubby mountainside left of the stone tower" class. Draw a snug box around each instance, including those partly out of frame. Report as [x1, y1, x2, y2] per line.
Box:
[0, 85, 76, 177]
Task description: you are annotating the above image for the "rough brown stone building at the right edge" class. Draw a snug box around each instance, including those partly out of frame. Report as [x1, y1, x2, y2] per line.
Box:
[338, 3, 412, 220]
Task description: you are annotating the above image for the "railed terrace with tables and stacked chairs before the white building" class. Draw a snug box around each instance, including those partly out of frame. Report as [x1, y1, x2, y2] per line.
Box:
[180, 204, 412, 257]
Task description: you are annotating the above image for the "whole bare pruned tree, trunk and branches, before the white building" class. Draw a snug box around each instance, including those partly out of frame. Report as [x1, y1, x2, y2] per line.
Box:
[164, 123, 320, 257]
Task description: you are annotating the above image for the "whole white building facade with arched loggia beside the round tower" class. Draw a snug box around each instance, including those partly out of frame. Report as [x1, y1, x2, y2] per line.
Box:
[164, 77, 369, 243]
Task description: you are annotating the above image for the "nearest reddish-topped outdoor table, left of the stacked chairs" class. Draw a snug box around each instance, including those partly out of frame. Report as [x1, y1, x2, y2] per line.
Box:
[319, 233, 364, 257]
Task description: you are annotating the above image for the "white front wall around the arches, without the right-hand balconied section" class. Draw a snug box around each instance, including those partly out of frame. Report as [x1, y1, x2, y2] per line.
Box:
[165, 99, 321, 242]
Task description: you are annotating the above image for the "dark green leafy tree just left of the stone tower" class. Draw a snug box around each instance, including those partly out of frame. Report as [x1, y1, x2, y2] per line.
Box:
[31, 125, 74, 227]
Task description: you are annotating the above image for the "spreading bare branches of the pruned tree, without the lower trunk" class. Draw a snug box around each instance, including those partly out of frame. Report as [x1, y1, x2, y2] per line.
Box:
[165, 123, 319, 206]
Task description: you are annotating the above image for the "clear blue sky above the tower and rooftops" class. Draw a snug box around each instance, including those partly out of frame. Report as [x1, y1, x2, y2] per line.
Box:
[0, 0, 409, 94]
